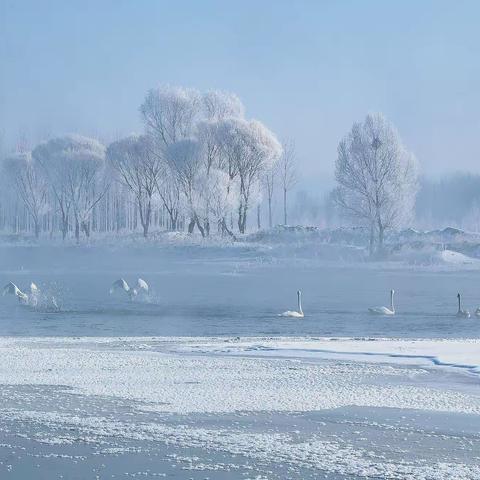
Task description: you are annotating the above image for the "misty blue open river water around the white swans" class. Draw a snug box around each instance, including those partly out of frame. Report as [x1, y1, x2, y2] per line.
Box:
[0, 246, 480, 338]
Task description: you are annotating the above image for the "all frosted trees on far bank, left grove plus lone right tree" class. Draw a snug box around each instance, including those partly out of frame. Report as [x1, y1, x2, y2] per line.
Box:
[0, 91, 419, 254]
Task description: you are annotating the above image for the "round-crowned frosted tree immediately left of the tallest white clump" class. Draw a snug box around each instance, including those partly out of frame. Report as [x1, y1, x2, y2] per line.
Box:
[106, 135, 163, 237]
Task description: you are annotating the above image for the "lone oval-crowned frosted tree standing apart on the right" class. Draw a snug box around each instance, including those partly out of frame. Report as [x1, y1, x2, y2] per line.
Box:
[335, 114, 417, 253]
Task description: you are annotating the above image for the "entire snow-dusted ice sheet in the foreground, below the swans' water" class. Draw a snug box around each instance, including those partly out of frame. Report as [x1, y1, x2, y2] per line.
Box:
[0, 337, 480, 480]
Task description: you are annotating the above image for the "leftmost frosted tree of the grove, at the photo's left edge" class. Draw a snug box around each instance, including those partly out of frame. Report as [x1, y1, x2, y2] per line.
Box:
[3, 152, 48, 238]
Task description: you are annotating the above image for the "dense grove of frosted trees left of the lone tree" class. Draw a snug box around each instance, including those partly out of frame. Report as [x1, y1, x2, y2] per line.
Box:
[0, 86, 296, 242]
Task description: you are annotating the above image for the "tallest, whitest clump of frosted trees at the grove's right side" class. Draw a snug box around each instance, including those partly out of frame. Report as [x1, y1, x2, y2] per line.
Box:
[140, 86, 281, 235]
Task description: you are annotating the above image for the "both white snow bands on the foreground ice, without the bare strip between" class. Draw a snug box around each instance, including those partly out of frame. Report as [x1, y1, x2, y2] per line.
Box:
[0, 337, 480, 480]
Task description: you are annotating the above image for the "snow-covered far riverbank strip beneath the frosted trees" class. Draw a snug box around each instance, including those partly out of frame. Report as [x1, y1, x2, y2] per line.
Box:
[0, 225, 480, 270]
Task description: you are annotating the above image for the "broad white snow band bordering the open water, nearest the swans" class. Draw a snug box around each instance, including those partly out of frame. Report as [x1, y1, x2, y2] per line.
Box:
[0, 337, 480, 414]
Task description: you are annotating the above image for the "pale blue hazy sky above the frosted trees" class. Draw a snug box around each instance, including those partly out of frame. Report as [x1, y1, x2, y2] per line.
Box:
[0, 0, 480, 186]
